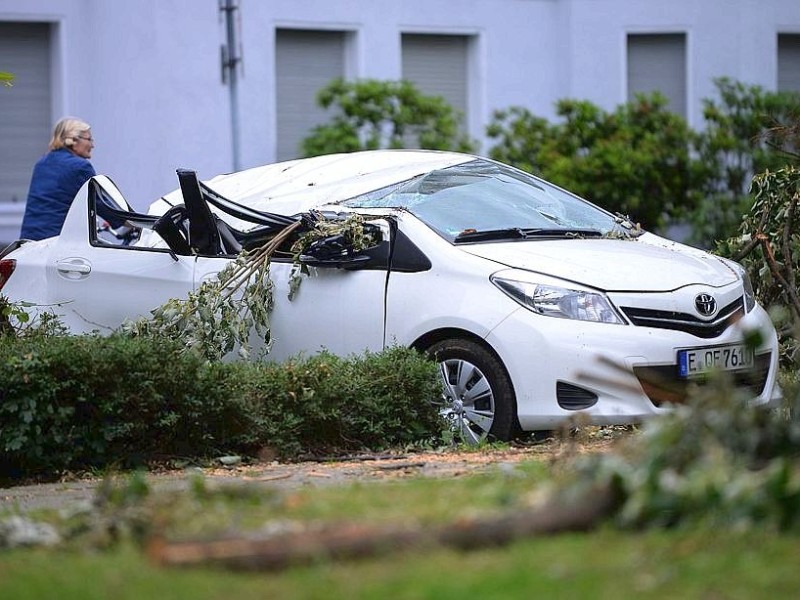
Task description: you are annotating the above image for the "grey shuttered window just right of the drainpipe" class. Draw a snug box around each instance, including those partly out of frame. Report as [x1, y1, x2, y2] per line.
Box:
[275, 29, 346, 161]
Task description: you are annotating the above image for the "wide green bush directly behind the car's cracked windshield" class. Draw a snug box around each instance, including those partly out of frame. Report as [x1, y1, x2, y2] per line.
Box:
[487, 93, 694, 228]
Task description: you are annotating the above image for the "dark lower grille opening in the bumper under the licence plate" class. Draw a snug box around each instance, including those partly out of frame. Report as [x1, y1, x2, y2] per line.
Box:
[633, 352, 772, 407]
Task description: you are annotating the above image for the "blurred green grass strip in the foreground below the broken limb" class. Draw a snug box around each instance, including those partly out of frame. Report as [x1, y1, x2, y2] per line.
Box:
[0, 530, 800, 600]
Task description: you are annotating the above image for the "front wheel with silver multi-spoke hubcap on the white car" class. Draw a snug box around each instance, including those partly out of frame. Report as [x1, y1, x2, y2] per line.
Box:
[427, 338, 519, 444]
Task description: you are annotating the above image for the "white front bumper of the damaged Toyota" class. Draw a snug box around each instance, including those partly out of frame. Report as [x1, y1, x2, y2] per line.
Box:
[486, 306, 782, 430]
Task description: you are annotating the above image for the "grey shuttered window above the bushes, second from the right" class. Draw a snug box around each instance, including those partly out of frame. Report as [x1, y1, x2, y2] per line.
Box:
[628, 33, 687, 118]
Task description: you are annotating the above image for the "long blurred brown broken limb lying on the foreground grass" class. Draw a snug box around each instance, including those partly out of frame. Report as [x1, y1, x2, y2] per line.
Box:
[147, 485, 619, 571]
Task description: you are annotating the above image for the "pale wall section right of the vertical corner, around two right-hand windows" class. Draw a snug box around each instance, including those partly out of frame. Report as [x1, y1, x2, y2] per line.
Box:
[558, 0, 800, 127]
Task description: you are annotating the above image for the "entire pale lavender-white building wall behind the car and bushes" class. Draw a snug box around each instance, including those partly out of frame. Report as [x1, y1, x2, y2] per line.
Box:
[0, 0, 800, 241]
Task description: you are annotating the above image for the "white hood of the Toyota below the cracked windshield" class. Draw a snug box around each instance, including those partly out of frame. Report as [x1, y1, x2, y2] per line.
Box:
[458, 233, 738, 292]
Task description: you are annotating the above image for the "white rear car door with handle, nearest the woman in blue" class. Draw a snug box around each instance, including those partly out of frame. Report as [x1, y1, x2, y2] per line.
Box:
[45, 181, 200, 333]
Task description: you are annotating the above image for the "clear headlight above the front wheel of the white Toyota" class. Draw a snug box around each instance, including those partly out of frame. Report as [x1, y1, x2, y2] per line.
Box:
[491, 272, 625, 325]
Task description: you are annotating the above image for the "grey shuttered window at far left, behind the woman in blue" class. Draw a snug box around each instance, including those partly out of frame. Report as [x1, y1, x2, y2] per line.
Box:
[0, 22, 53, 204]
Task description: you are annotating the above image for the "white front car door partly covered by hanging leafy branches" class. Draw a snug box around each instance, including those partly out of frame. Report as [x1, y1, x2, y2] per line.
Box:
[197, 221, 390, 361]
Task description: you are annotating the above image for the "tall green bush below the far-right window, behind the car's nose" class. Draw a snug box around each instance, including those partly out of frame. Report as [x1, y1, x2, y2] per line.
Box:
[691, 78, 800, 242]
